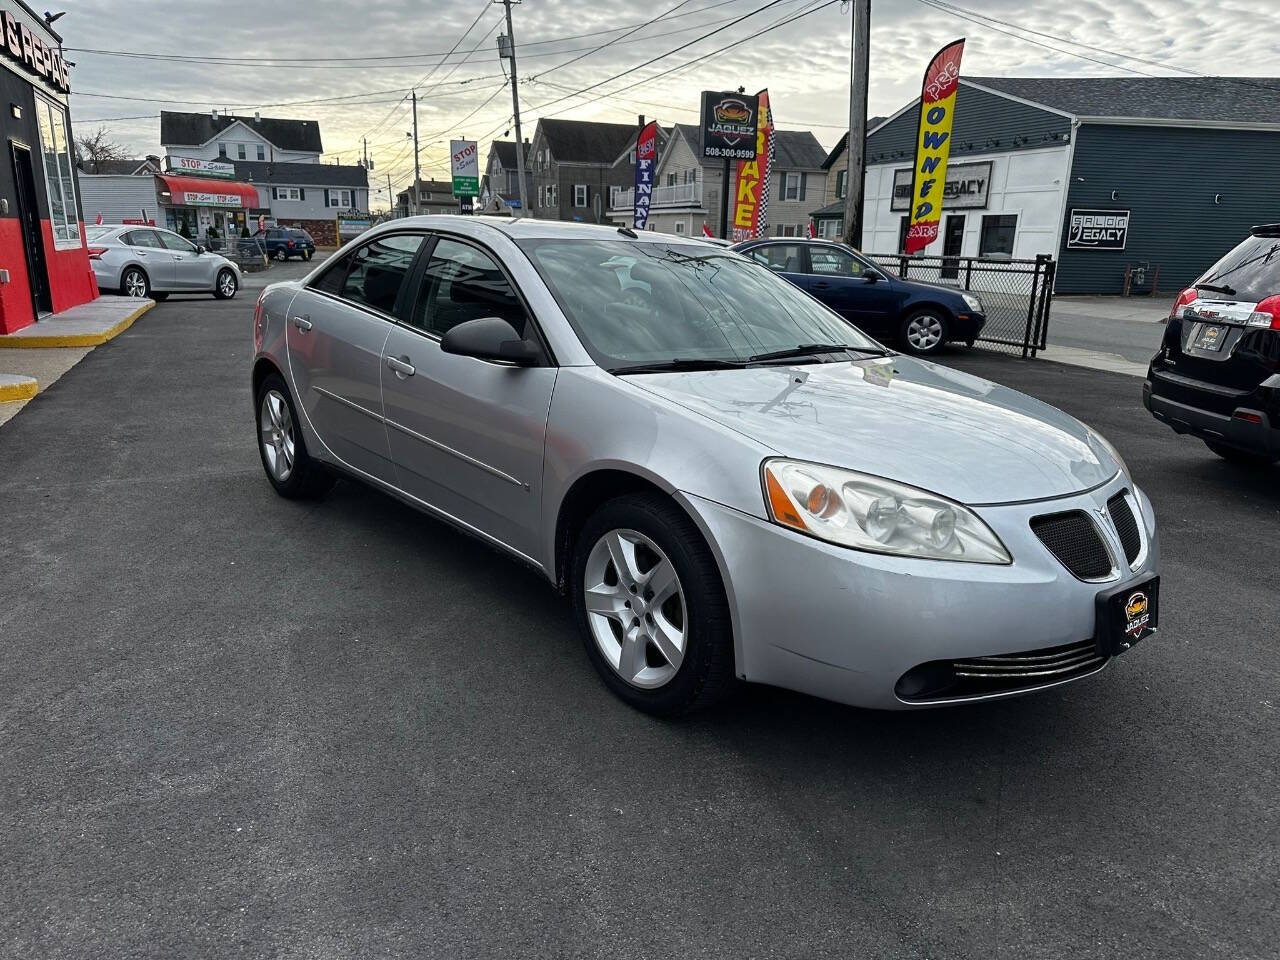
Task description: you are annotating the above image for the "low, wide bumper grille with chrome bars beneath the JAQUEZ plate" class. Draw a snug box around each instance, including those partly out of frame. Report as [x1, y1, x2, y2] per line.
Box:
[896, 640, 1107, 701]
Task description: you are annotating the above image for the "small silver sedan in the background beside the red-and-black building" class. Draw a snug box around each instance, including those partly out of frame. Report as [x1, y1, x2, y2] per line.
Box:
[86, 225, 241, 300]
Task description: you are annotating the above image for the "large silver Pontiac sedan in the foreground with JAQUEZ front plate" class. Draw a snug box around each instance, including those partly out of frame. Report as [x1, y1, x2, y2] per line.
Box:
[252, 216, 1160, 716]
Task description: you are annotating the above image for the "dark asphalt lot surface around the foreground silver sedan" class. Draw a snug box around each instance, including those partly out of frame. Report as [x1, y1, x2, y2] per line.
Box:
[0, 297, 1280, 960]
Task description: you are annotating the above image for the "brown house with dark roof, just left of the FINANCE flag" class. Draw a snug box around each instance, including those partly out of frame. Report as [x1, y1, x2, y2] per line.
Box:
[529, 119, 639, 223]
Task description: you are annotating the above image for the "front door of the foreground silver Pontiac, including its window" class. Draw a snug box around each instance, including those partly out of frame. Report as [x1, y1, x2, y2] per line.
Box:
[381, 237, 557, 558]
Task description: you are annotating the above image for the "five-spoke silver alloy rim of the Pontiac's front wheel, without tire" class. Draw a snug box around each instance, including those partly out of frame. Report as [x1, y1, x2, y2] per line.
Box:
[584, 530, 689, 690]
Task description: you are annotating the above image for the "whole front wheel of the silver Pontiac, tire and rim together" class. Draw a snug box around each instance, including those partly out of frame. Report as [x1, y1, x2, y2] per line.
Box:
[570, 495, 733, 717]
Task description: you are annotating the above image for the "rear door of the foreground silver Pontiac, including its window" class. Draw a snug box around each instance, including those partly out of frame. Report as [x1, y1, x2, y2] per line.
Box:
[285, 233, 426, 484]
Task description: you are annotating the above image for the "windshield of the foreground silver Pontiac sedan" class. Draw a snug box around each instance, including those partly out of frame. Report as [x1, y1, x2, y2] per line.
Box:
[520, 238, 878, 370]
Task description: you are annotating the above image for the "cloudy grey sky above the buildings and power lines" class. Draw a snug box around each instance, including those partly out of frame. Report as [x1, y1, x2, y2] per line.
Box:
[57, 0, 1280, 206]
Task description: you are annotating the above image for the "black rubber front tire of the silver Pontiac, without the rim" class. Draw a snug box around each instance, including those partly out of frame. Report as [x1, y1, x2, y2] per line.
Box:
[568, 494, 733, 717]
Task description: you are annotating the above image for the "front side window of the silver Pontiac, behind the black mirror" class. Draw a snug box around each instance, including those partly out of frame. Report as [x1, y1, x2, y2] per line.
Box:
[410, 238, 526, 337]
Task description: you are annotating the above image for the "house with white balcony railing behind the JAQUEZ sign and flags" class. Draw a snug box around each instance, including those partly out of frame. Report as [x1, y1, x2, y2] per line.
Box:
[609, 123, 827, 237]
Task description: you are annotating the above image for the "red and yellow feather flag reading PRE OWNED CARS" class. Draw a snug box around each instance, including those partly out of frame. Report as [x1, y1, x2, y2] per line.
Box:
[904, 37, 964, 253]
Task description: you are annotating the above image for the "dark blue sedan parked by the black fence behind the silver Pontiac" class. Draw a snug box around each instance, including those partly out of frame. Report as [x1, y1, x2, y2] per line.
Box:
[733, 237, 987, 353]
